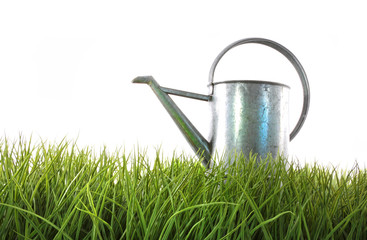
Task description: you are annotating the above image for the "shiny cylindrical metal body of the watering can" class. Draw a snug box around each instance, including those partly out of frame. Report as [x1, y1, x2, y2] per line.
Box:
[209, 81, 289, 167]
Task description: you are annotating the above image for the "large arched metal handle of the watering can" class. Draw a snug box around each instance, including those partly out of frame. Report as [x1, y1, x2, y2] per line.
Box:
[209, 38, 310, 141]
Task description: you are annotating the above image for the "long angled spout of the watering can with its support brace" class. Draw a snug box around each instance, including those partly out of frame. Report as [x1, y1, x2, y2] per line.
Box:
[132, 76, 211, 168]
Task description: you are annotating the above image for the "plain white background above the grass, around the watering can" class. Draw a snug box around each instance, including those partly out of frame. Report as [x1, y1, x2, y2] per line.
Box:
[0, 0, 367, 167]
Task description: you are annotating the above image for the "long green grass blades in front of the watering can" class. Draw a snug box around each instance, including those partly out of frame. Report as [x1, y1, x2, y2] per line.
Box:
[0, 136, 367, 240]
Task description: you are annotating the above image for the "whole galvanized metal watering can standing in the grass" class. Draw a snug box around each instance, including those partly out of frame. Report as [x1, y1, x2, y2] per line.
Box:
[133, 38, 310, 168]
